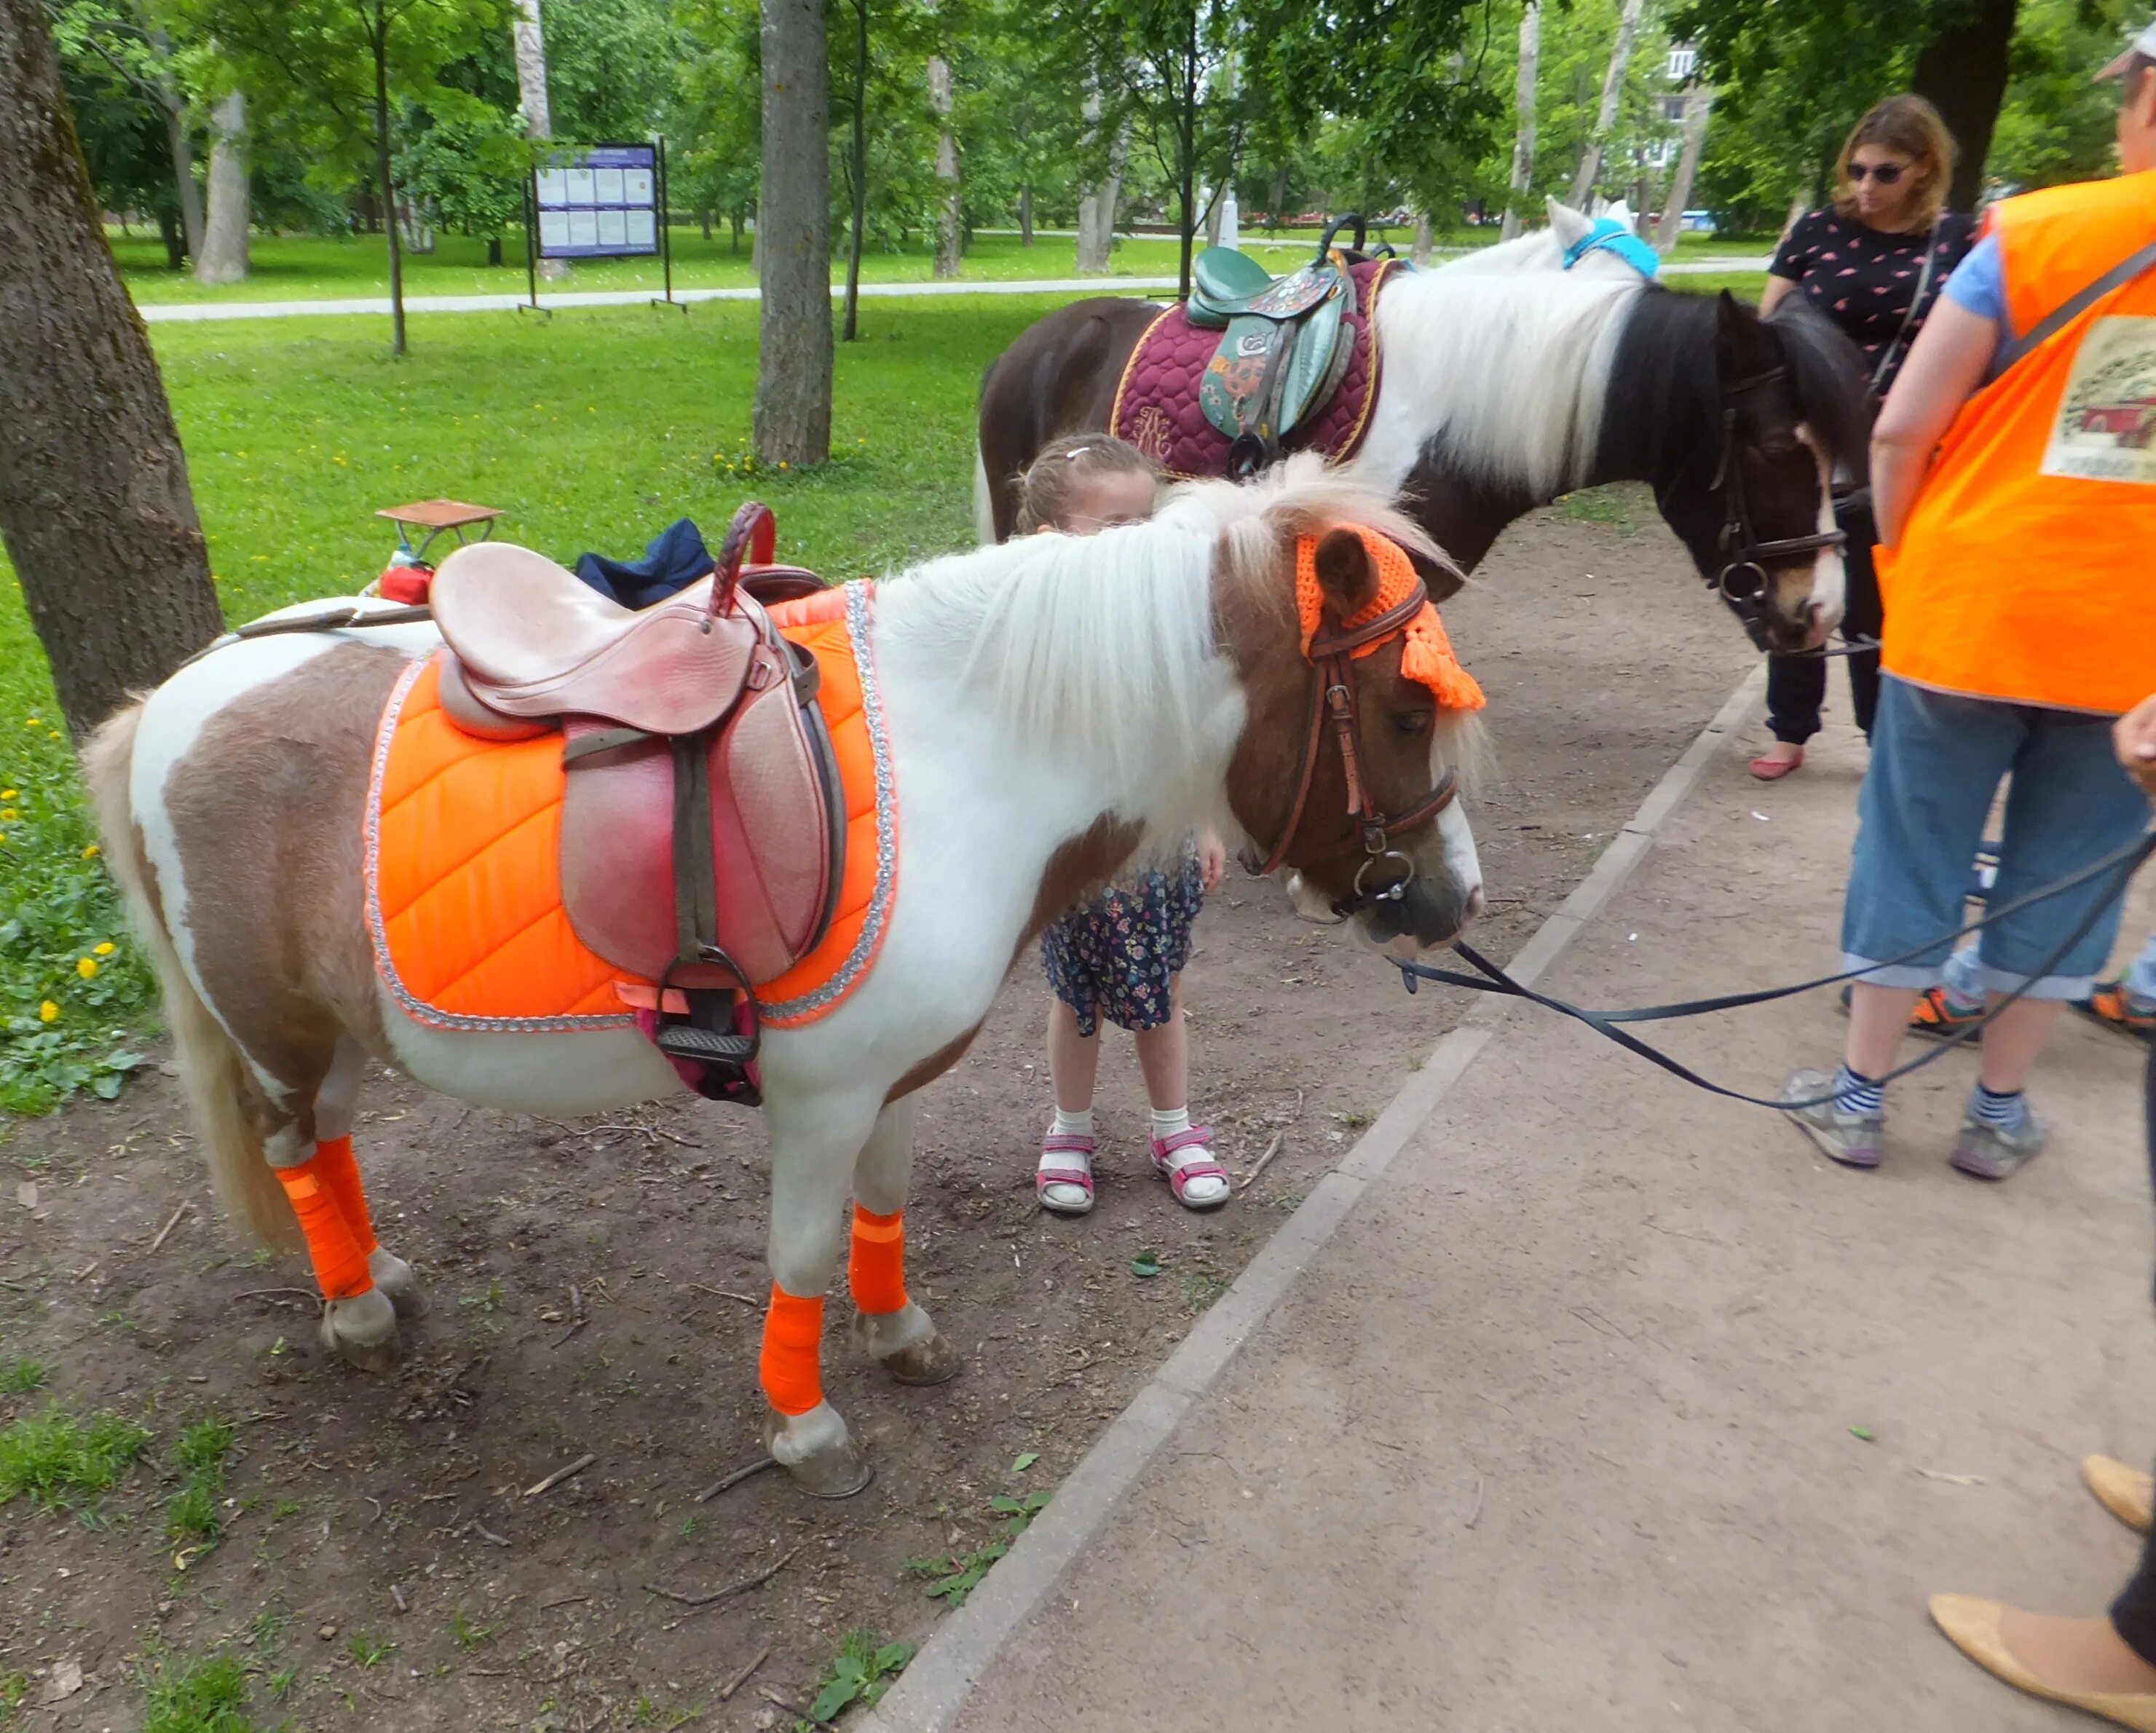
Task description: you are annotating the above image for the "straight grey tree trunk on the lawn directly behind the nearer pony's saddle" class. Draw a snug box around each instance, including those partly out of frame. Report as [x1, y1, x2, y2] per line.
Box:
[754, 0, 832, 467]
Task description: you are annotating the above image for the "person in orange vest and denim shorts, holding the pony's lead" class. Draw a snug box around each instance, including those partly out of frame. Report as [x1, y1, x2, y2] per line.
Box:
[1783, 26, 2156, 1207]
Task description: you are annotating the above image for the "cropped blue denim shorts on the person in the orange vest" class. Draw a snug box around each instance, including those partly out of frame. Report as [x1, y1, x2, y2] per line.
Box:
[1841, 675, 2149, 998]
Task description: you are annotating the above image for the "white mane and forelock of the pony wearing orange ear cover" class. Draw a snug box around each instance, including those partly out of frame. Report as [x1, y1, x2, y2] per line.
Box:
[877, 457, 1442, 837]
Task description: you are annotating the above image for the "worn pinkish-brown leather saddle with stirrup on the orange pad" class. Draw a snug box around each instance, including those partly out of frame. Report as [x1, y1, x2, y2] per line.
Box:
[429, 502, 845, 1102]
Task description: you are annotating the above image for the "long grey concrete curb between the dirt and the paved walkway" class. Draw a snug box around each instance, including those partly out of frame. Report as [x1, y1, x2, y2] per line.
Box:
[858, 662, 1766, 1733]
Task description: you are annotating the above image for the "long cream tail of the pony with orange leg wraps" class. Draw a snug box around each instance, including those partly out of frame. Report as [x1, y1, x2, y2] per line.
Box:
[82, 698, 304, 1252]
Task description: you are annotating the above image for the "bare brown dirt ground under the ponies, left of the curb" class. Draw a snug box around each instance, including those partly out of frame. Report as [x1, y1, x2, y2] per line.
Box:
[0, 502, 1748, 1731]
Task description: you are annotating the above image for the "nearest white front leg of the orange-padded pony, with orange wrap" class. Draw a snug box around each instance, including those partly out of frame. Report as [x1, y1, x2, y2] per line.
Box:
[757, 1095, 877, 1498]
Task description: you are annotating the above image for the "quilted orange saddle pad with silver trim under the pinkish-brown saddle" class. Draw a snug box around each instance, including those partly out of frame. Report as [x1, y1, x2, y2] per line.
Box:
[364, 584, 899, 1033]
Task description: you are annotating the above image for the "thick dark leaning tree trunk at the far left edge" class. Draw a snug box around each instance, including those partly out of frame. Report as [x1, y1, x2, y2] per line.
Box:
[0, 0, 224, 735]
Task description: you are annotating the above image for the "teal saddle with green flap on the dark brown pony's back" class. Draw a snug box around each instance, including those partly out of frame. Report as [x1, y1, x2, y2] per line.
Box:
[1184, 218, 1388, 481]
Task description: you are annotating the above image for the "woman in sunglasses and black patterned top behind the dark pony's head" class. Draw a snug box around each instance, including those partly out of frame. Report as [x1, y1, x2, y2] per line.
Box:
[1750, 97, 1975, 783]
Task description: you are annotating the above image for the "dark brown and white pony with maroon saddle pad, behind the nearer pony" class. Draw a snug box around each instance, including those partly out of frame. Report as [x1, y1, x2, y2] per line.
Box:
[974, 269, 1871, 651]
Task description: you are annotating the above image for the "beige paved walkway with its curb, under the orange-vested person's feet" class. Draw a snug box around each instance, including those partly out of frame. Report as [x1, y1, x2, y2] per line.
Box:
[871, 679, 2156, 1733]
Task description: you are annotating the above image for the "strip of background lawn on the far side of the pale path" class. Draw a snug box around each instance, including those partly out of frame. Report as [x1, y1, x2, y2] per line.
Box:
[108, 224, 1768, 304]
